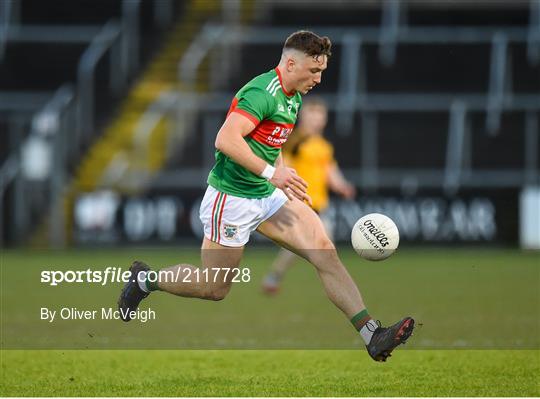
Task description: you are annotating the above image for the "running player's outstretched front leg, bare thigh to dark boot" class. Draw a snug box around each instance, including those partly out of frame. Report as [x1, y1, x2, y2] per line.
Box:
[258, 199, 414, 361]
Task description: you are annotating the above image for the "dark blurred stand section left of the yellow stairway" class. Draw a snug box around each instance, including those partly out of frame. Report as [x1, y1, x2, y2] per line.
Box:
[0, 0, 184, 242]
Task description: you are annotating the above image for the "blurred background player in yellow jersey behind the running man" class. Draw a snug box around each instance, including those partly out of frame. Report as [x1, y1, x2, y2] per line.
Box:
[262, 96, 356, 294]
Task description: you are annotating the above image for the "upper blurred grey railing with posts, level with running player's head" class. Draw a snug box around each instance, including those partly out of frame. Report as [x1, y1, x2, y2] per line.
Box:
[178, 23, 536, 135]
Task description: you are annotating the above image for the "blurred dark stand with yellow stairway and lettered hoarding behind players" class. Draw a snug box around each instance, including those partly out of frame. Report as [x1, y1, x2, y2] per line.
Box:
[0, 0, 540, 249]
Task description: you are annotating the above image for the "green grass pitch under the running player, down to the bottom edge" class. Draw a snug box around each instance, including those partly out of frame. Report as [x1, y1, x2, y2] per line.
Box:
[0, 249, 540, 396]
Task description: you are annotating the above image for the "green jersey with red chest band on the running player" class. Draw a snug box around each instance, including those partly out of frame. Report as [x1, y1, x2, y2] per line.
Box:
[208, 68, 302, 198]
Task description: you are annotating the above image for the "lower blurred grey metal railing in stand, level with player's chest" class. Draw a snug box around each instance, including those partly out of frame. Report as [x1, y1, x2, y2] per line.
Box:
[142, 93, 540, 193]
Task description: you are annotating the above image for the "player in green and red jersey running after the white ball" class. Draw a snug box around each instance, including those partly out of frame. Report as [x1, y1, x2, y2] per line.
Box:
[118, 31, 414, 361]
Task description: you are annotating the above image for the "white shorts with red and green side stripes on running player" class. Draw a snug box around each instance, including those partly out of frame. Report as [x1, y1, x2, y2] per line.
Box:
[199, 186, 288, 247]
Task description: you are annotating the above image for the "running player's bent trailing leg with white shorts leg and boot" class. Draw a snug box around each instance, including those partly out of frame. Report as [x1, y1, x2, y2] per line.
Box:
[118, 187, 257, 321]
